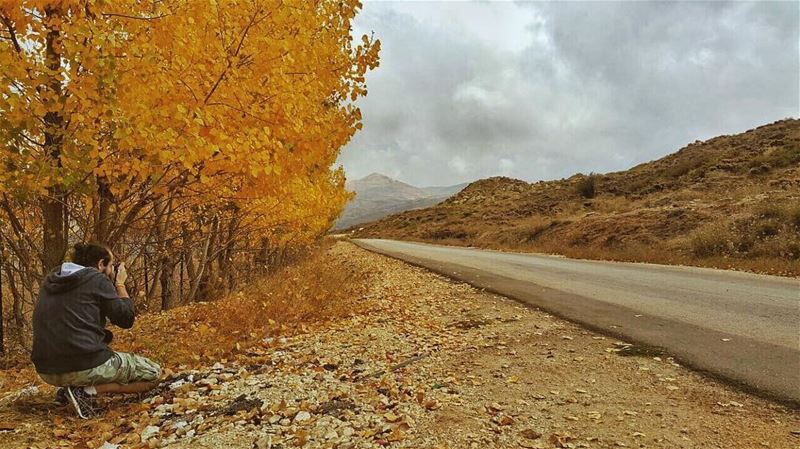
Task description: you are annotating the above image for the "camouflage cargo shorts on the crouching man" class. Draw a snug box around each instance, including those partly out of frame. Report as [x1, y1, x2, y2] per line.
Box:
[39, 352, 161, 387]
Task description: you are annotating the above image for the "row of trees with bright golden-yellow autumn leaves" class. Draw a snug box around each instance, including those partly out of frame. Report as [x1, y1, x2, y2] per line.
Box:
[0, 0, 380, 350]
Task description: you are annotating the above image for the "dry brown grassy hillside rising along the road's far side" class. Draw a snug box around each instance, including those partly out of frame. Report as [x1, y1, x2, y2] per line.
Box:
[353, 119, 800, 275]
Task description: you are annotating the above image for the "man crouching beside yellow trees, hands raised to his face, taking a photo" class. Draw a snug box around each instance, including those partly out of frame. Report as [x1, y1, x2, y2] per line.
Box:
[31, 243, 161, 419]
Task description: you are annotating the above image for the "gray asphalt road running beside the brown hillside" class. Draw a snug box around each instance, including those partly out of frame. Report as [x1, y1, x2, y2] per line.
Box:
[353, 239, 800, 406]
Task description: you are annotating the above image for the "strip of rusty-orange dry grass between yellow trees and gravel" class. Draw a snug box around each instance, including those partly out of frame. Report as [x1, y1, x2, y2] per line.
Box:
[115, 245, 366, 367]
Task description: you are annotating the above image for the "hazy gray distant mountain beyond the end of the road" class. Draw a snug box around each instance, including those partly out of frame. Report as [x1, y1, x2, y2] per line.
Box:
[334, 173, 468, 230]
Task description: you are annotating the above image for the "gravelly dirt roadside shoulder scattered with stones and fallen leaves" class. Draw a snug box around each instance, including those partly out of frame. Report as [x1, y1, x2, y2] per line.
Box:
[0, 242, 800, 449]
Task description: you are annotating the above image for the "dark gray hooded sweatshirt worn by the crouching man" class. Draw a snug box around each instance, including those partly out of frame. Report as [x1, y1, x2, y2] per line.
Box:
[31, 262, 134, 374]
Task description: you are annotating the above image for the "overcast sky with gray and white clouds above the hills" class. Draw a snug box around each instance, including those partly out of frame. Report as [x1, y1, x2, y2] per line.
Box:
[339, 1, 800, 186]
